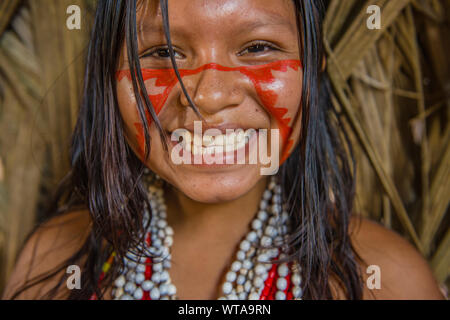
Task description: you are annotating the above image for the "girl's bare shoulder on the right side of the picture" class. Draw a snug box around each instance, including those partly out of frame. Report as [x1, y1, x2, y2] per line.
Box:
[350, 218, 443, 300]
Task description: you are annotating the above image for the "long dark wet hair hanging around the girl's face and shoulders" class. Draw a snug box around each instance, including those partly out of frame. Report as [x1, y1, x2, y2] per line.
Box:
[10, 0, 362, 299]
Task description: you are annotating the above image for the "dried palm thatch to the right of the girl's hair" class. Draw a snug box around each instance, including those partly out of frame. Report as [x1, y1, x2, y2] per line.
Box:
[325, 0, 450, 282]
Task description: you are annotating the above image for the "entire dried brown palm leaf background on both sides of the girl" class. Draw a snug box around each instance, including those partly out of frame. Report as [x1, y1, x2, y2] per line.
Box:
[0, 0, 450, 296]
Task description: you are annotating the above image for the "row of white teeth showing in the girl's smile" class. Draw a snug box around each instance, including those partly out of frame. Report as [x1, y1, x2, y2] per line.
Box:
[174, 130, 256, 156]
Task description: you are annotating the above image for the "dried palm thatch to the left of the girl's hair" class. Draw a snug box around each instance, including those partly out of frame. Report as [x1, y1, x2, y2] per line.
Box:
[0, 0, 90, 288]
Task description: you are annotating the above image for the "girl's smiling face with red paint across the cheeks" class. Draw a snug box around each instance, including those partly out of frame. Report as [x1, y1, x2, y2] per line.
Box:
[117, 0, 303, 203]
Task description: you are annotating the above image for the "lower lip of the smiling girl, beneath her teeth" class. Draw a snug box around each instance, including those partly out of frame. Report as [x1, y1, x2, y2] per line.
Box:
[168, 132, 259, 169]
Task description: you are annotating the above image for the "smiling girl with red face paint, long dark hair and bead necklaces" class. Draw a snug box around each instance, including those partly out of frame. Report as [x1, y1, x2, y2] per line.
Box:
[4, 0, 442, 299]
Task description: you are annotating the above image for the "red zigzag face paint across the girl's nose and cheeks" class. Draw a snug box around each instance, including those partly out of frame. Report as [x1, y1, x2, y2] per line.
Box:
[117, 60, 302, 163]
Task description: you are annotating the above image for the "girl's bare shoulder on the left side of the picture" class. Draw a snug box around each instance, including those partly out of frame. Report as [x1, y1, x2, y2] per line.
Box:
[3, 211, 91, 300]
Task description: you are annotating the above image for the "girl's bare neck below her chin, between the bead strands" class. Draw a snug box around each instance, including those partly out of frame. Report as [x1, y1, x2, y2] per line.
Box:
[165, 179, 267, 241]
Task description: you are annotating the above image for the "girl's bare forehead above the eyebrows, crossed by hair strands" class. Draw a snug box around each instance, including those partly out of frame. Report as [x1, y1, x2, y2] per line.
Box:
[137, 0, 297, 33]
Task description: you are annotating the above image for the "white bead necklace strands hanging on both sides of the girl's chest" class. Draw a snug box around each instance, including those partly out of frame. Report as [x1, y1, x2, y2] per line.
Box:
[113, 178, 302, 300]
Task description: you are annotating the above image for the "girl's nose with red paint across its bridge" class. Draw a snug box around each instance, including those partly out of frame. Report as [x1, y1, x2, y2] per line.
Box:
[181, 64, 245, 114]
